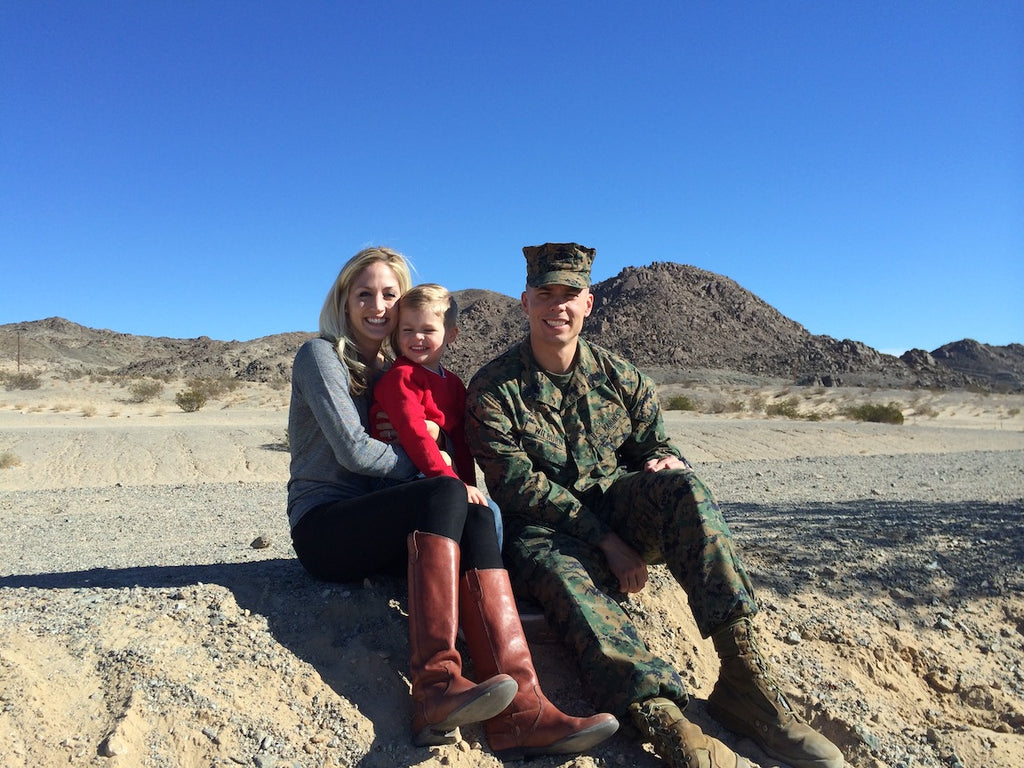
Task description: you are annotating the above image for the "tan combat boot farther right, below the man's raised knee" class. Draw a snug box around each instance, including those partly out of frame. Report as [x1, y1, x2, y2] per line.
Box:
[708, 617, 844, 768]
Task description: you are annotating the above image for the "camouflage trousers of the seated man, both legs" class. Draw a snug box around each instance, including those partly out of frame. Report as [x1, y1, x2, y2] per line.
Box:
[505, 469, 757, 716]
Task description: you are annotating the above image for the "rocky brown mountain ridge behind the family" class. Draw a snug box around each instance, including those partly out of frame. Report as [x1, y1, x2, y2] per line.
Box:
[0, 262, 1024, 391]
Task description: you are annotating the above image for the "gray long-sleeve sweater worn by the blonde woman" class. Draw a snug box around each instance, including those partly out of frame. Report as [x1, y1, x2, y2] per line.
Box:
[288, 339, 418, 528]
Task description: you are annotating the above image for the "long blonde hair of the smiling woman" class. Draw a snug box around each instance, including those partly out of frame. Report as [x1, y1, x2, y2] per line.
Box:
[319, 246, 413, 396]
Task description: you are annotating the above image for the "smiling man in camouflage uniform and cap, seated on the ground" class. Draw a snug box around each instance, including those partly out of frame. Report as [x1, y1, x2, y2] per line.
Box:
[466, 243, 843, 768]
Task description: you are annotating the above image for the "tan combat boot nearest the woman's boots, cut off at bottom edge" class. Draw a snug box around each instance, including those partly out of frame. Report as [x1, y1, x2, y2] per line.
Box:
[630, 698, 751, 768]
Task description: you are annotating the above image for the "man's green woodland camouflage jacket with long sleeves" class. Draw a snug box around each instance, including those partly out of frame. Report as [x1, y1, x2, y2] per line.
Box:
[466, 338, 682, 544]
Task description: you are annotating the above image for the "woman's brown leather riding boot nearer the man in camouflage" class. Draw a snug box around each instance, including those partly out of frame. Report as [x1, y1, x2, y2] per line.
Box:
[459, 568, 618, 760]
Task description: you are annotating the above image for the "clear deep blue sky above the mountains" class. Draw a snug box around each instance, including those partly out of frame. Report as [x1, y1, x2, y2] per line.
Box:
[0, 0, 1024, 353]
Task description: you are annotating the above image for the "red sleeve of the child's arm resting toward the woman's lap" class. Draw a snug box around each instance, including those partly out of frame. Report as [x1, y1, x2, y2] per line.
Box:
[374, 366, 458, 477]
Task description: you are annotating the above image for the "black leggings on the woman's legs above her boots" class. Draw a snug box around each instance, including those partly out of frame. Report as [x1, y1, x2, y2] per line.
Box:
[292, 477, 505, 582]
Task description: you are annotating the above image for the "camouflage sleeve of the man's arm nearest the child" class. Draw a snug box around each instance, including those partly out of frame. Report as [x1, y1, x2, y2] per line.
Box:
[466, 378, 610, 544]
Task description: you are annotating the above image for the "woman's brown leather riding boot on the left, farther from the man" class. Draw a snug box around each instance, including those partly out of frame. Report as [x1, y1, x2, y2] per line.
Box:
[409, 531, 516, 746]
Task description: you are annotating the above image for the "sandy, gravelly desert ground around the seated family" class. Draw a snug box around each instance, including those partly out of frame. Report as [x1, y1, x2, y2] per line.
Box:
[0, 376, 1024, 768]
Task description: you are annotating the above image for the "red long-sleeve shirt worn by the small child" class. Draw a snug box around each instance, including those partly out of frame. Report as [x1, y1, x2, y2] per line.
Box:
[370, 356, 476, 485]
